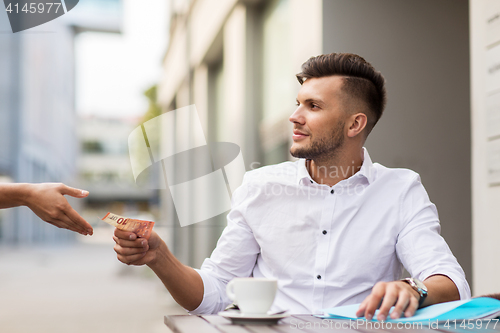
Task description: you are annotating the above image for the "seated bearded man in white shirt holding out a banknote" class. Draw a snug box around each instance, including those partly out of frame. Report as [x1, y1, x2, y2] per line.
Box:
[114, 53, 470, 320]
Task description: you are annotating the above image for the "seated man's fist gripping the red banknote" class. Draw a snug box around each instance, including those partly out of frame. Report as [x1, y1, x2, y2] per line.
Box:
[113, 229, 162, 265]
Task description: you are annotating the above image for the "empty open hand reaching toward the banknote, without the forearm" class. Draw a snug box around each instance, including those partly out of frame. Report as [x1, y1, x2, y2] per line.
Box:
[24, 183, 93, 235]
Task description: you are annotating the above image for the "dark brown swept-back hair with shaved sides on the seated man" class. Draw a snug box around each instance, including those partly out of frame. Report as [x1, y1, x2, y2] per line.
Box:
[296, 53, 387, 134]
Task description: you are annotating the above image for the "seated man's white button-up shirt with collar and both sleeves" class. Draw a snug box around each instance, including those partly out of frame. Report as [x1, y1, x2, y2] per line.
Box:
[191, 149, 470, 314]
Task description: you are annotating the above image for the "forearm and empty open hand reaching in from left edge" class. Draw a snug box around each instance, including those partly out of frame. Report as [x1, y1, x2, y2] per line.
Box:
[0, 183, 93, 236]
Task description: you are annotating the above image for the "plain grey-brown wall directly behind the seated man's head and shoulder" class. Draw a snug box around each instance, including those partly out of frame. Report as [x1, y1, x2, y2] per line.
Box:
[323, 0, 470, 282]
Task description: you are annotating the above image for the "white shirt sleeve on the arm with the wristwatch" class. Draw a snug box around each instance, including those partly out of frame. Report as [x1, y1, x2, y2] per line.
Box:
[396, 175, 471, 299]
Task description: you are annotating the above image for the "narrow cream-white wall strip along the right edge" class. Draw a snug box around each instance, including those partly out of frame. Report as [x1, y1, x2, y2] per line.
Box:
[470, 0, 500, 295]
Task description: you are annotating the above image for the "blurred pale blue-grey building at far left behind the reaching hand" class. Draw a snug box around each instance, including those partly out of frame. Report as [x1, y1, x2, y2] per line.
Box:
[0, 0, 121, 243]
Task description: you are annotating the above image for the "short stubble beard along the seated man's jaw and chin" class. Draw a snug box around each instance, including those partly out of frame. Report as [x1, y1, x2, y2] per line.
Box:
[290, 122, 345, 161]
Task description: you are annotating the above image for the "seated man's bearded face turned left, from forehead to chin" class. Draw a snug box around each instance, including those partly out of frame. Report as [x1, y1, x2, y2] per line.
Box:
[290, 76, 347, 159]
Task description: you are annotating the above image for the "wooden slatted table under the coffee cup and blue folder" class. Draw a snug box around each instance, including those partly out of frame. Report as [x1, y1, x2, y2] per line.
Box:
[164, 315, 500, 333]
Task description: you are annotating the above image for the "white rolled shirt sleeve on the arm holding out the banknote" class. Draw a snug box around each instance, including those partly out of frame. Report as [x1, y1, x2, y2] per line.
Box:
[186, 176, 260, 314]
